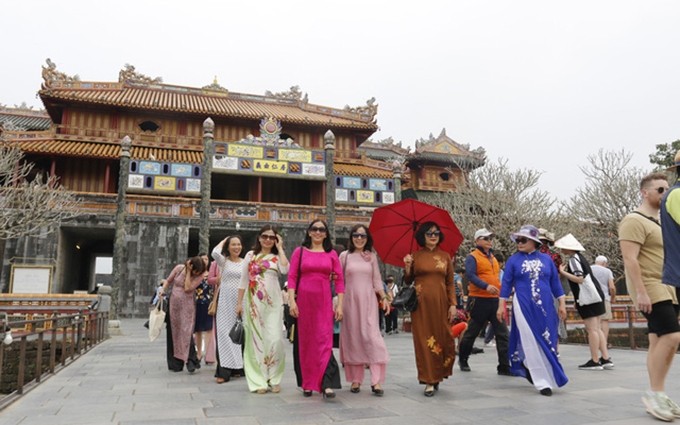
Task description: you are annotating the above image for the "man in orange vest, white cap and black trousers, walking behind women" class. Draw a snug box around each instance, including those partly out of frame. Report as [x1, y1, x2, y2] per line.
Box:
[458, 229, 512, 376]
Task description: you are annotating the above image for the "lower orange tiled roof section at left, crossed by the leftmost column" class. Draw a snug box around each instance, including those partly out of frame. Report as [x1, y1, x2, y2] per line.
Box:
[18, 140, 203, 164]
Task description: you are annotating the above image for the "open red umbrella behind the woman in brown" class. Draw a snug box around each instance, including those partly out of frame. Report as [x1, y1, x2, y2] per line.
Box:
[369, 199, 463, 267]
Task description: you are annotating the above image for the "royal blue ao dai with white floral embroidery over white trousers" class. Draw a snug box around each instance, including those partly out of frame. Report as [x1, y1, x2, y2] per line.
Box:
[500, 251, 568, 390]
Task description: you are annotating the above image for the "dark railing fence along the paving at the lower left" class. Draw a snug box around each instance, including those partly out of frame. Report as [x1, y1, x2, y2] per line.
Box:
[0, 309, 109, 410]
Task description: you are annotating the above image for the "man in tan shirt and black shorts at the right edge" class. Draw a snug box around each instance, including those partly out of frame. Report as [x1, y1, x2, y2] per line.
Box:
[619, 173, 680, 422]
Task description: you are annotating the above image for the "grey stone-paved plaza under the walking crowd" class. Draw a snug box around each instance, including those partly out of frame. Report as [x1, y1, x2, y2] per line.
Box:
[0, 319, 680, 425]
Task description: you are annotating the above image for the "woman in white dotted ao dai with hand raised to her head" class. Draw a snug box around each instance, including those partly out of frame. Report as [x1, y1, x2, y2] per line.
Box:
[212, 235, 243, 384]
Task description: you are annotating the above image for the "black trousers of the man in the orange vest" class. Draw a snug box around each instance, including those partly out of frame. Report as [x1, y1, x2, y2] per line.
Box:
[459, 297, 510, 367]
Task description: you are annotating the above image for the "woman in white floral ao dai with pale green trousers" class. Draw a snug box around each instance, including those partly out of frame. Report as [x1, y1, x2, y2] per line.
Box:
[236, 224, 288, 394]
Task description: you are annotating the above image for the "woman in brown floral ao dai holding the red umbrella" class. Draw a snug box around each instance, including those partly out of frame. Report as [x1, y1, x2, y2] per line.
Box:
[404, 221, 457, 397]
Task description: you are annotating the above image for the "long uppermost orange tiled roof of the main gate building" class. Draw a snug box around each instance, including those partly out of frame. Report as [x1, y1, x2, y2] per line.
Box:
[39, 81, 378, 132]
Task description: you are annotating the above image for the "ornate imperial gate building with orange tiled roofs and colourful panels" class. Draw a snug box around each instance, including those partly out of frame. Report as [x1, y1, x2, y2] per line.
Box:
[0, 59, 484, 315]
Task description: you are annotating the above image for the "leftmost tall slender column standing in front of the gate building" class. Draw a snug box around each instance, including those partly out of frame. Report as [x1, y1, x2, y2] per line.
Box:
[112, 136, 132, 316]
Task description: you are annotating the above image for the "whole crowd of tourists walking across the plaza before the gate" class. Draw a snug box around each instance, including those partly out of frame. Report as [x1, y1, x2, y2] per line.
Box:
[154, 151, 680, 421]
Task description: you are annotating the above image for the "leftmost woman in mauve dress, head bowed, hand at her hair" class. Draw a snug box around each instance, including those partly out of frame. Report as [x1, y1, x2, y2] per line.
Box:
[160, 256, 207, 373]
